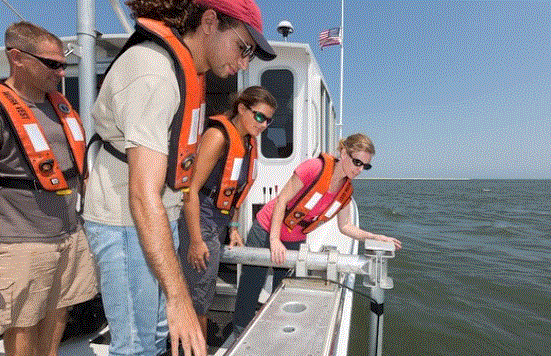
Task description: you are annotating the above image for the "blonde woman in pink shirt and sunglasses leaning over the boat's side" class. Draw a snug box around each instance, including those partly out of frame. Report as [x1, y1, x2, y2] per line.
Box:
[233, 133, 402, 333]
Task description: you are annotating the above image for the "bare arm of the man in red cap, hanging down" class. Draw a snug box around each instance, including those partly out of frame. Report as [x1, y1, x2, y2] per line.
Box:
[126, 146, 207, 356]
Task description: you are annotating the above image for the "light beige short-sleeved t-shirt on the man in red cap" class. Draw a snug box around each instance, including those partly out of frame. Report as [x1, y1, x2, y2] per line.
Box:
[83, 42, 182, 226]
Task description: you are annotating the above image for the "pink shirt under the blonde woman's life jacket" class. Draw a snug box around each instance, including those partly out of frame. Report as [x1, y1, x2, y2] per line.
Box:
[256, 158, 337, 242]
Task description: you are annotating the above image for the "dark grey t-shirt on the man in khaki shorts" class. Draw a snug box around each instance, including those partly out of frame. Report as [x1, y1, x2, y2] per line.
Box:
[0, 100, 81, 242]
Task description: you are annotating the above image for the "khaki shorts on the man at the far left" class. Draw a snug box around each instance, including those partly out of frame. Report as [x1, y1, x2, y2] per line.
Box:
[0, 229, 97, 334]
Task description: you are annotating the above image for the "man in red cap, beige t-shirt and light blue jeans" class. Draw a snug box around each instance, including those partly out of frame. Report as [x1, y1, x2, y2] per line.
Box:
[83, 0, 275, 356]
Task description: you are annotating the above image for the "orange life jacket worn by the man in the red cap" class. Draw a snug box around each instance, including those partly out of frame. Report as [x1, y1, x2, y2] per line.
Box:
[96, 17, 205, 191]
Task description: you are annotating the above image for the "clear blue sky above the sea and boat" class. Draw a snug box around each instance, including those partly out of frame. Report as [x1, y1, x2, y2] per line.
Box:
[0, 0, 551, 179]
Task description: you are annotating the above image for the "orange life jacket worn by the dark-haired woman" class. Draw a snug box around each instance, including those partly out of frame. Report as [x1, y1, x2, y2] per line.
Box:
[210, 115, 258, 213]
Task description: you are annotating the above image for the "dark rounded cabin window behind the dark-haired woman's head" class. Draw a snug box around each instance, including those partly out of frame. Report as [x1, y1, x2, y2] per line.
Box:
[260, 69, 295, 158]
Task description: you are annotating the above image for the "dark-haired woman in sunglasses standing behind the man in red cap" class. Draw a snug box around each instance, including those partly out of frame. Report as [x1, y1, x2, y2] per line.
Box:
[179, 86, 277, 335]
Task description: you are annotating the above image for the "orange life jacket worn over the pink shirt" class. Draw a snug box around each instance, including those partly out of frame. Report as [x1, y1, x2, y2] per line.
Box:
[283, 153, 354, 234]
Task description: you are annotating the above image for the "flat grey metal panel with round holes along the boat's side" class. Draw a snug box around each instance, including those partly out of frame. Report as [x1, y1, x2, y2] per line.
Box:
[227, 279, 342, 356]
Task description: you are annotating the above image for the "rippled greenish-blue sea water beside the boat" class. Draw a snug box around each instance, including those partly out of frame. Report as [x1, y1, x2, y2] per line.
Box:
[349, 180, 551, 356]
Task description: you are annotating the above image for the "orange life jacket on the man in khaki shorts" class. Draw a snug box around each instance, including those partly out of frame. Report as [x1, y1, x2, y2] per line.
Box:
[0, 84, 86, 194]
